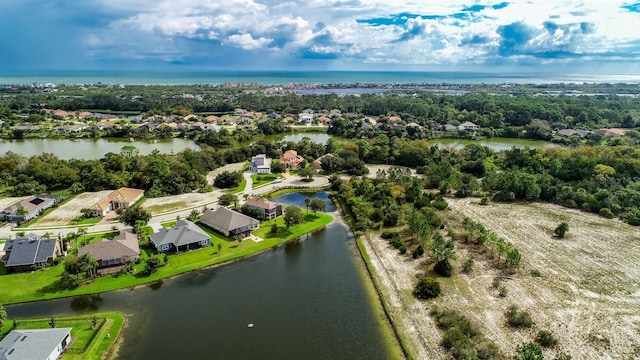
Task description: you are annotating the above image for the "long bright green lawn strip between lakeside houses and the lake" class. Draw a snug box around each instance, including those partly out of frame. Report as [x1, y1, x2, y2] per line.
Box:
[0, 213, 332, 304]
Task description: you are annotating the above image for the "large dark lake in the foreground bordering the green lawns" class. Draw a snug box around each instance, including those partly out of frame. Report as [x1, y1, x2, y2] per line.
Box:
[7, 194, 398, 359]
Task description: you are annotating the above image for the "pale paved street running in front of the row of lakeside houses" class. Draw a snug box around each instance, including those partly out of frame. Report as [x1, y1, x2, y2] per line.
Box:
[0, 173, 329, 239]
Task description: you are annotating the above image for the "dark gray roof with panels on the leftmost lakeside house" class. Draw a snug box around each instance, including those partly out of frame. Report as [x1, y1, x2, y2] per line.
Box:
[5, 234, 57, 266]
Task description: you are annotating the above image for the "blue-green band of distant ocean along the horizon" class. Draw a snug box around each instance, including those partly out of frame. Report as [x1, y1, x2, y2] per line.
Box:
[0, 70, 640, 85]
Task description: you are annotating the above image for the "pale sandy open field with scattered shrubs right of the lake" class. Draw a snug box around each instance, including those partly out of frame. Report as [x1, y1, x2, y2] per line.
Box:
[364, 199, 640, 359]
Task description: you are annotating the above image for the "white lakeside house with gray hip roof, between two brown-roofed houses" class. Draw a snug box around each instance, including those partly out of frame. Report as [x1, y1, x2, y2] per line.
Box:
[149, 220, 211, 253]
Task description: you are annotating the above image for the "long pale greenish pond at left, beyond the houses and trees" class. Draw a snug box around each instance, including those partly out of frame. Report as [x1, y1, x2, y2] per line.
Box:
[0, 138, 200, 160]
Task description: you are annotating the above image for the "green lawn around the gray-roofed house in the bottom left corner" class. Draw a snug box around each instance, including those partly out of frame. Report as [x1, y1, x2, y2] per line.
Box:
[0, 313, 124, 360]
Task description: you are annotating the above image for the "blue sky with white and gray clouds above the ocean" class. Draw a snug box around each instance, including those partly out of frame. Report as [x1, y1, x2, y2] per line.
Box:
[0, 0, 640, 74]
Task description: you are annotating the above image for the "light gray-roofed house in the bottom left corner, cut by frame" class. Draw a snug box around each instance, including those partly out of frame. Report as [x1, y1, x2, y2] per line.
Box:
[0, 328, 71, 360]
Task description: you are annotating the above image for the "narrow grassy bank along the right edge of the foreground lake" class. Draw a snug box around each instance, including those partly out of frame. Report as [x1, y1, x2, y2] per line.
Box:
[332, 197, 413, 360]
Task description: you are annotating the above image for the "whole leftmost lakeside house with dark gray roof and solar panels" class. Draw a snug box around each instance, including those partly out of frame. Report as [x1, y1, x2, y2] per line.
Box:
[2, 234, 62, 272]
